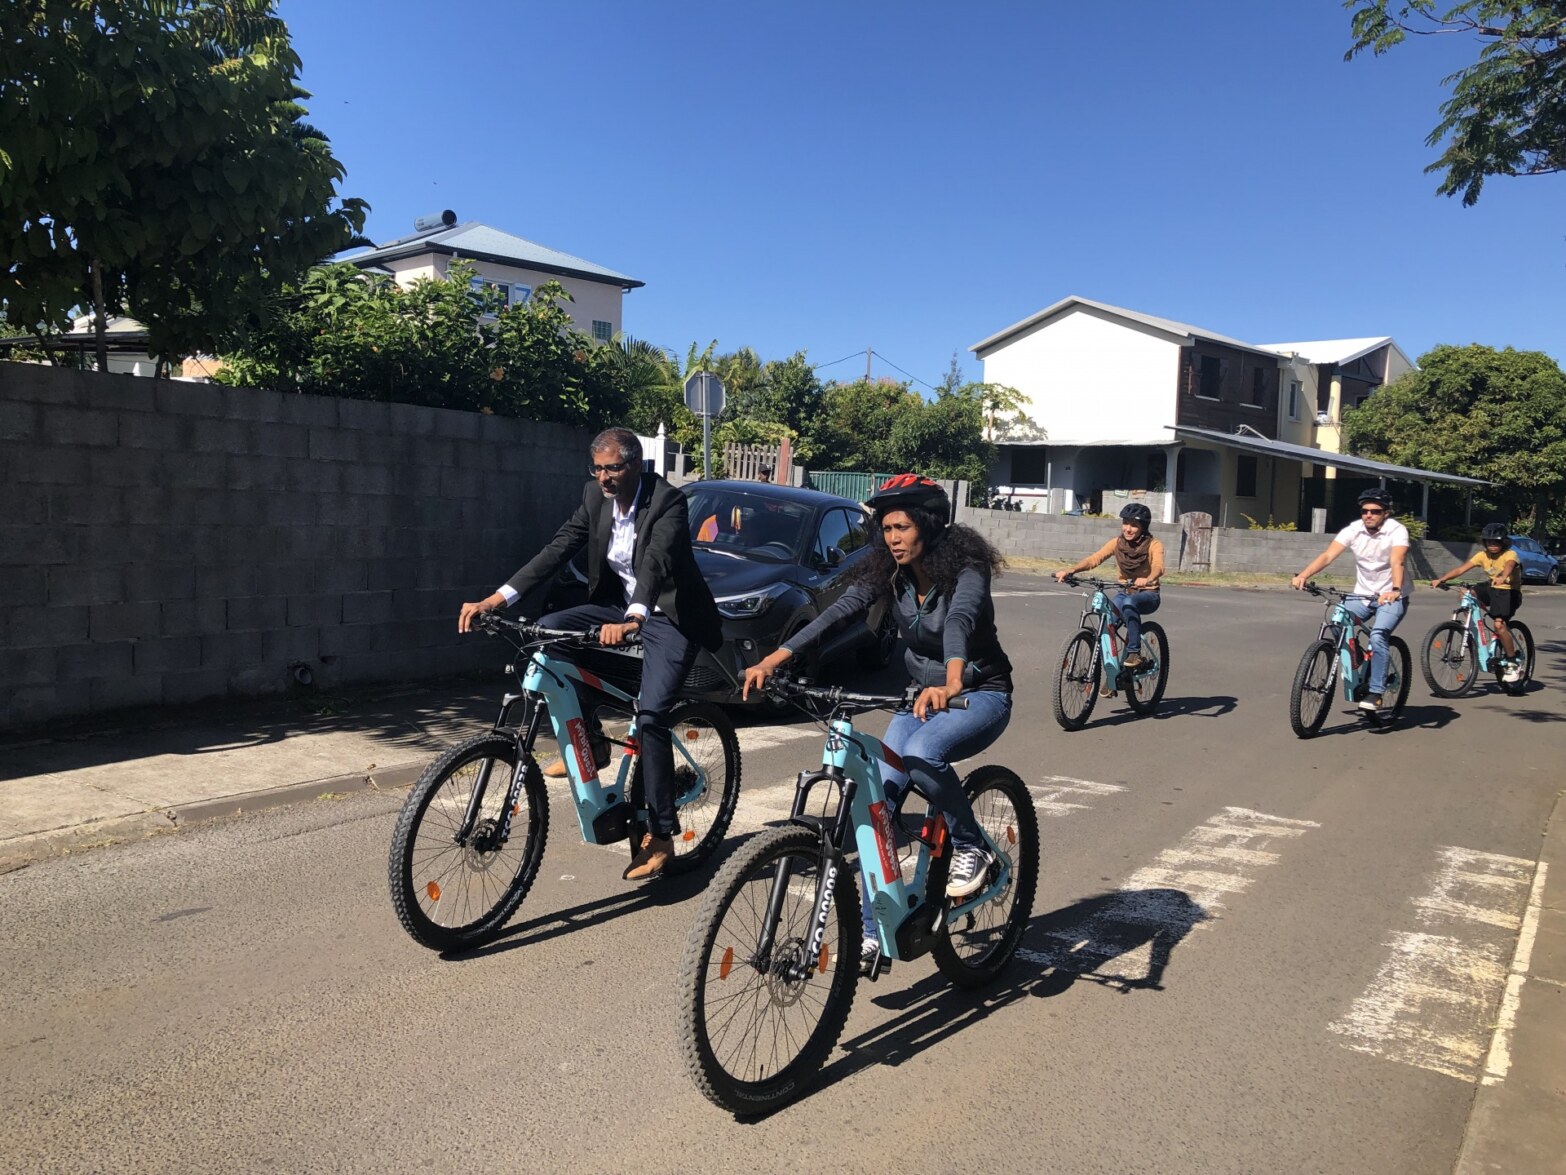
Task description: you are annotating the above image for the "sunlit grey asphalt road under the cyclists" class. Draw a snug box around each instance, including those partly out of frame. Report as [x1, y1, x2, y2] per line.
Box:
[0, 577, 1566, 1173]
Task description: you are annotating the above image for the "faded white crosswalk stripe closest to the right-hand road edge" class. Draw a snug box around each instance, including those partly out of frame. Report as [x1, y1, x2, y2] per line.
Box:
[1328, 844, 1544, 1083]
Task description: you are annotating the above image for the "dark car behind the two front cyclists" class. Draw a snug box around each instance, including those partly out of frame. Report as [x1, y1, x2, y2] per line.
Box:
[550, 481, 897, 702]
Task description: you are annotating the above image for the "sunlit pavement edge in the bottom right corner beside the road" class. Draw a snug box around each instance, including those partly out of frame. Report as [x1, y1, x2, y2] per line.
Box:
[1453, 793, 1566, 1175]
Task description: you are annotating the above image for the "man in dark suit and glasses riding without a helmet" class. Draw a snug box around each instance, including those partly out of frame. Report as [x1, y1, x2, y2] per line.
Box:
[457, 428, 722, 880]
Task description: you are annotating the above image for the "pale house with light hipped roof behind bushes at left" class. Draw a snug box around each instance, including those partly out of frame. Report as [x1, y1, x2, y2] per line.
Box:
[338, 208, 645, 343]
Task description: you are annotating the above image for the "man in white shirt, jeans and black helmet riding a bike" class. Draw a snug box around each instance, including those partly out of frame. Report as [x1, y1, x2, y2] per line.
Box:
[1290, 489, 1414, 714]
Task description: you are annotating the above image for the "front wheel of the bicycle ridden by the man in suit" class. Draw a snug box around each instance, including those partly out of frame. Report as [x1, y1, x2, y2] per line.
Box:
[387, 733, 550, 951]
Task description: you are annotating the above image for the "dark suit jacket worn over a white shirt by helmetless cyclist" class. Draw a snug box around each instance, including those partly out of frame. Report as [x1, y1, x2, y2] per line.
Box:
[507, 473, 723, 650]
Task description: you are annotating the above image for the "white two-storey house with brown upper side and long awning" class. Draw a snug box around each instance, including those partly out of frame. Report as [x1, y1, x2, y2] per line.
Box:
[969, 296, 1481, 530]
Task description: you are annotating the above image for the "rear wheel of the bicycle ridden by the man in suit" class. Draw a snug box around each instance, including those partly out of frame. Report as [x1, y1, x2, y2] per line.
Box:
[631, 702, 739, 873]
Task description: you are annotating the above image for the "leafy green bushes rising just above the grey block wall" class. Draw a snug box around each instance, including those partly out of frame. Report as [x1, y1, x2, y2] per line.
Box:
[218, 262, 633, 428]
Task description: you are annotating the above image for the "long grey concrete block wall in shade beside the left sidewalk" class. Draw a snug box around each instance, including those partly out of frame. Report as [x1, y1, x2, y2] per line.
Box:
[0, 363, 589, 730]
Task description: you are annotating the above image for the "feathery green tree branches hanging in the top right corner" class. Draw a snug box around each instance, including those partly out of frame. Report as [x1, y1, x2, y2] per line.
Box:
[1344, 0, 1566, 205]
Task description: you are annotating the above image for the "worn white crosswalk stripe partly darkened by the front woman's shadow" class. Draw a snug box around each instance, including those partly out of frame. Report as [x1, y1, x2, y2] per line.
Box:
[1018, 808, 1320, 987]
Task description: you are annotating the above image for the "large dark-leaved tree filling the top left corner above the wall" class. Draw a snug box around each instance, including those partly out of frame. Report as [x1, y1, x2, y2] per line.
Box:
[0, 0, 366, 368]
